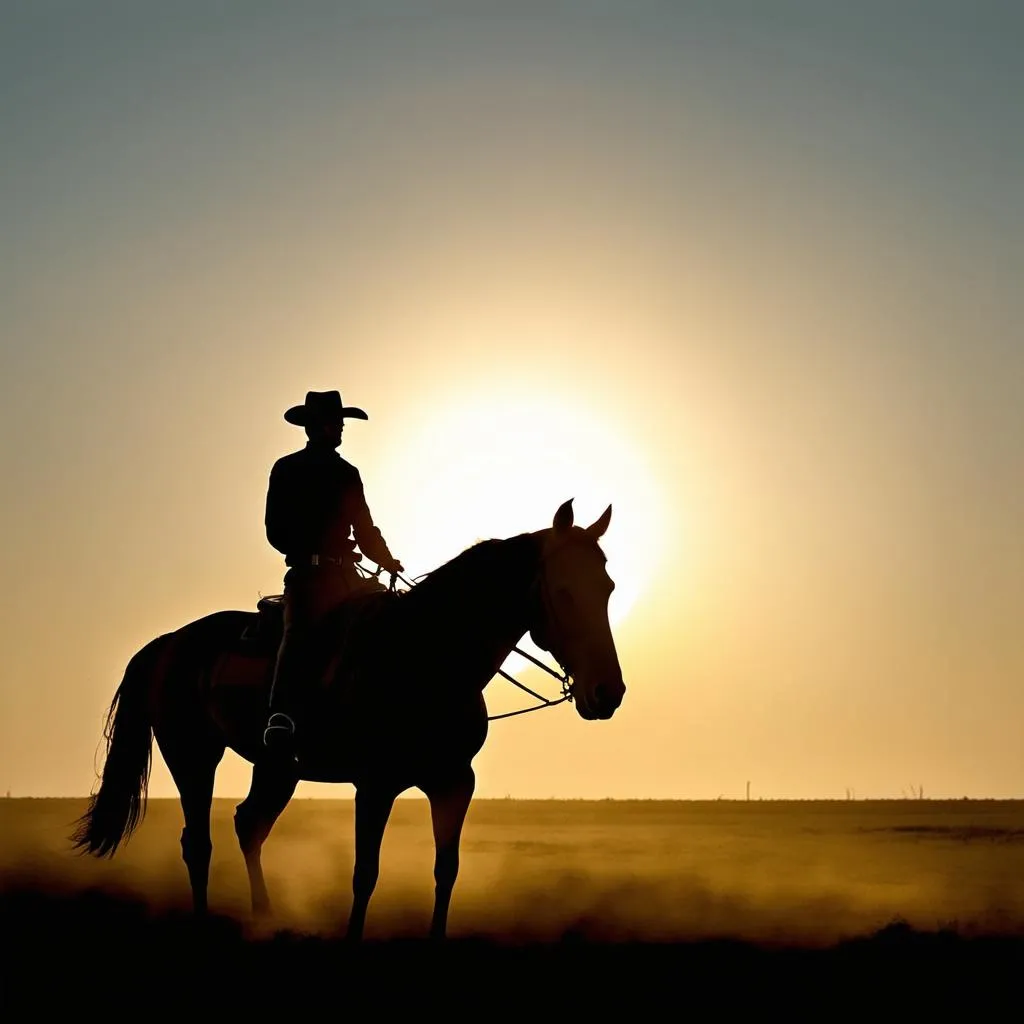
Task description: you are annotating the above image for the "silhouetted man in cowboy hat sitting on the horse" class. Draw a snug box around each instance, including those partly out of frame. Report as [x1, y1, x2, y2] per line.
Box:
[263, 391, 402, 756]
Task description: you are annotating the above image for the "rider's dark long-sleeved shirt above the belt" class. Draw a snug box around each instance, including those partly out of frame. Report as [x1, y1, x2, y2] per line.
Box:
[265, 441, 393, 565]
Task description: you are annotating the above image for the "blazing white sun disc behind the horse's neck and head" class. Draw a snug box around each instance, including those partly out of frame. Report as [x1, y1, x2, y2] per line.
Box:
[380, 387, 662, 624]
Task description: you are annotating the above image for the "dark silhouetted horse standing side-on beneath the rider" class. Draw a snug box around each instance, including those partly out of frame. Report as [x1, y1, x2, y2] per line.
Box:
[71, 499, 626, 940]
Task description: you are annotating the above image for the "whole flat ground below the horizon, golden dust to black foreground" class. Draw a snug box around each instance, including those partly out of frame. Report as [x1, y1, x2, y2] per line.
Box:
[0, 800, 1024, 1008]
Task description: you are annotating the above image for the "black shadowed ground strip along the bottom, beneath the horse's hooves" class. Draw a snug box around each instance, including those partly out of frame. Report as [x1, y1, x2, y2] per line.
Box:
[0, 889, 1024, 1021]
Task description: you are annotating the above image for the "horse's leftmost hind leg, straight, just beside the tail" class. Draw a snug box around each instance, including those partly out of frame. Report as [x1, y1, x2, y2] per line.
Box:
[157, 736, 224, 914]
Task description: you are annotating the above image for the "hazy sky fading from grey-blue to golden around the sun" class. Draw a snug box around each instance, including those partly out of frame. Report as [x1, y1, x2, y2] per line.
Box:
[0, 0, 1024, 799]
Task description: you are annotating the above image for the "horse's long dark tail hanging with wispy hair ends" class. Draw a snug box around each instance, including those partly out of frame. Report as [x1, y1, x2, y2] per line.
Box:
[71, 635, 170, 857]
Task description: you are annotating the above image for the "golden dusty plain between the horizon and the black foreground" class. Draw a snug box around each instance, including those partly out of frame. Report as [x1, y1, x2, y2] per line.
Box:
[0, 800, 1024, 946]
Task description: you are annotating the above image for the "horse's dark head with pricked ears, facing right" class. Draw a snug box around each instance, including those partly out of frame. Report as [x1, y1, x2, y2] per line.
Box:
[529, 499, 626, 719]
